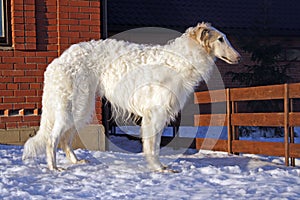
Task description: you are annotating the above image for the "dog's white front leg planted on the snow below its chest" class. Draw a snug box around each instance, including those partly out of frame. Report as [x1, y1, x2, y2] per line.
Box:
[141, 108, 167, 171]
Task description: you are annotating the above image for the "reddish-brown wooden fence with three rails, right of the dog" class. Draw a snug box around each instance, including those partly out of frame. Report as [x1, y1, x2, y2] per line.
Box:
[194, 83, 300, 166]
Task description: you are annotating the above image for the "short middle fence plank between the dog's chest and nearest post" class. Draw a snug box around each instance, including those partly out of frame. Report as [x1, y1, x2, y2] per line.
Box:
[194, 114, 227, 126]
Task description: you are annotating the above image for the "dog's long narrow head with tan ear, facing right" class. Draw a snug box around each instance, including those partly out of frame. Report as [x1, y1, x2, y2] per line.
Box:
[186, 22, 241, 64]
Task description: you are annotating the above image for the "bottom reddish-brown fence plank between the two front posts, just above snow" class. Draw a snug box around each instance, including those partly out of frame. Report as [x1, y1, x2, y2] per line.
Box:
[232, 140, 285, 156]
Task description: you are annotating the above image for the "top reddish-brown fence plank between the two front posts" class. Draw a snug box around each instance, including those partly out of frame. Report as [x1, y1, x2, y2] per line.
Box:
[230, 85, 284, 101]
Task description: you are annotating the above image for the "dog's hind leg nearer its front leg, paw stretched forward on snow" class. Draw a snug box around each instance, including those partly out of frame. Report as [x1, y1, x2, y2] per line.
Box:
[61, 127, 88, 164]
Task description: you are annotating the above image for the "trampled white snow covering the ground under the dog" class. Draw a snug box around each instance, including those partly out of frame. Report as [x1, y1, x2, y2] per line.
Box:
[0, 137, 300, 200]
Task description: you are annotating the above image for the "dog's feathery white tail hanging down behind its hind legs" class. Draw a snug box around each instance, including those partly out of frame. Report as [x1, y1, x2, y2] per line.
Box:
[22, 116, 49, 160]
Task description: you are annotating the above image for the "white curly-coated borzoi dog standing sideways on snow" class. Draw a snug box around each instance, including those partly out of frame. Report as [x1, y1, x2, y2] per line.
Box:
[23, 23, 240, 171]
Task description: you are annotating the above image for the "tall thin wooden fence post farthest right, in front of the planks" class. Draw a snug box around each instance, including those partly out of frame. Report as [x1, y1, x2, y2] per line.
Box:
[284, 83, 290, 166]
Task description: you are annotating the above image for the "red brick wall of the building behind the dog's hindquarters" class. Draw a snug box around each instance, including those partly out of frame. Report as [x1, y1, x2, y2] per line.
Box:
[0, 0, 101, 129]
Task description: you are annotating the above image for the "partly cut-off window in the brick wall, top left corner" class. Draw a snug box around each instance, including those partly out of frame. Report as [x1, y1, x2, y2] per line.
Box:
[0, 0, 11, 46]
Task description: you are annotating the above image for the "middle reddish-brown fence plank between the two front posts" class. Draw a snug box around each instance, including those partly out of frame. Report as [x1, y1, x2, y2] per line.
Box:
[231, 113, 284, 126]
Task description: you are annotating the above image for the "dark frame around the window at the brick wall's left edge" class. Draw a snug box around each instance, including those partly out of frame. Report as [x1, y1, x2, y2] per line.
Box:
[0, 0, 11, 46]
